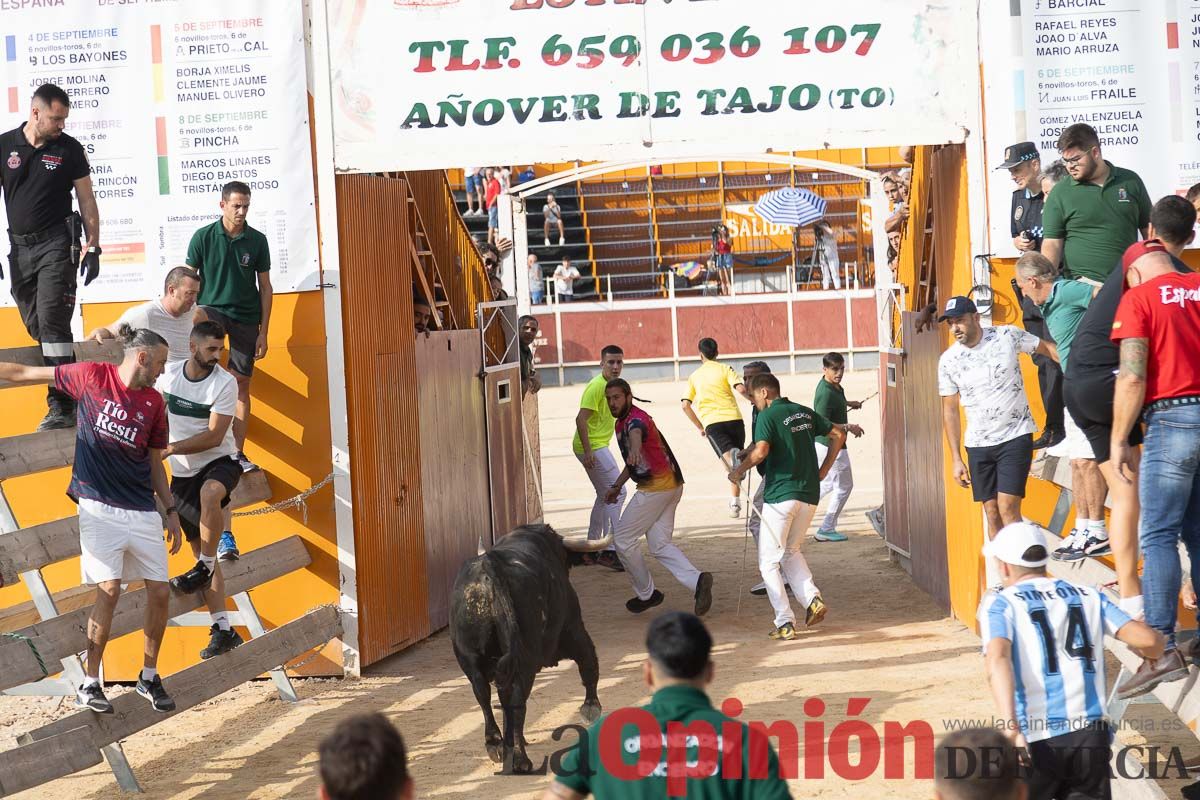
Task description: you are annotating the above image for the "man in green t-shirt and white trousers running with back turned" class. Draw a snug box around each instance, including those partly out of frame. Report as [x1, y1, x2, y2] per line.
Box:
[730, 373, 846, 640]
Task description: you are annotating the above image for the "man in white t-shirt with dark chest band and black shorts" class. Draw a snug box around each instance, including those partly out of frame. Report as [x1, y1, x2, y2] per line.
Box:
[155, 321, 241, 658]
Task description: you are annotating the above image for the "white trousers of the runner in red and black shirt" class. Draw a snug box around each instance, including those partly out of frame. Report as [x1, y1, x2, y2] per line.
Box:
[616, 486, 700, 600]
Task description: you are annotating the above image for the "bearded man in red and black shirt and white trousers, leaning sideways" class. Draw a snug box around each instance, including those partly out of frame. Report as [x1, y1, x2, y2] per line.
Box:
[605, 378, 713, 616]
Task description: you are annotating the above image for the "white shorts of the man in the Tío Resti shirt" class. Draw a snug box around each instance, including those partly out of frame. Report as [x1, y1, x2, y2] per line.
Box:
[79, 498, 168, 584]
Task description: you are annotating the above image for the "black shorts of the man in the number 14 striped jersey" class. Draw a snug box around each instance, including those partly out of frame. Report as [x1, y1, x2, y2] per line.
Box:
[1026, 722, 1112, 800]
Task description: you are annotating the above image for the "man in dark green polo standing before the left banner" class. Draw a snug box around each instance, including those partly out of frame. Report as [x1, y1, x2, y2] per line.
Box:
[187, 181, 272, 473]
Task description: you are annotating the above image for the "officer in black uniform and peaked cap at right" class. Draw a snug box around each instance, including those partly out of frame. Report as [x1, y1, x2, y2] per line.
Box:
[996, 142, 1067, 450]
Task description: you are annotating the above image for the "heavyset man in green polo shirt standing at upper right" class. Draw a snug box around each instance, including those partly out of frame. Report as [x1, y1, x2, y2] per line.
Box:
[1042, 122, 1153, 285]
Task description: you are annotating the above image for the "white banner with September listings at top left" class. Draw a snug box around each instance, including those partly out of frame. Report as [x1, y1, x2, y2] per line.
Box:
[0, 0, 318, 305]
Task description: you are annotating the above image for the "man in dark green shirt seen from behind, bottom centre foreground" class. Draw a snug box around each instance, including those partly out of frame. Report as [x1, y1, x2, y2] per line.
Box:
[542, 612, 798, 800]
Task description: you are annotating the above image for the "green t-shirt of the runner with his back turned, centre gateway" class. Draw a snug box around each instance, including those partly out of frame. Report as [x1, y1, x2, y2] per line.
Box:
[754, 397, 833, 505]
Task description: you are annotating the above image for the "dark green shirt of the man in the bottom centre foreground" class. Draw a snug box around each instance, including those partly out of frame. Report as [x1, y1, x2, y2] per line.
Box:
[554, 685, 792, 800]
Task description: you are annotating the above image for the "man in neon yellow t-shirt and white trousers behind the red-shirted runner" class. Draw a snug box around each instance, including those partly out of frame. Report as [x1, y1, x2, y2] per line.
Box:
[572, 344, 625, 571]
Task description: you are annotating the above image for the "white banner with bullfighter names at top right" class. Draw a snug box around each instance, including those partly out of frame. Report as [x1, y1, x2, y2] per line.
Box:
[980, 0, 1200, 258]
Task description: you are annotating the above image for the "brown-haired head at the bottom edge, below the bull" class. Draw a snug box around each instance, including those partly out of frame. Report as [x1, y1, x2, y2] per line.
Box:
[319, 712, 413, 800]
